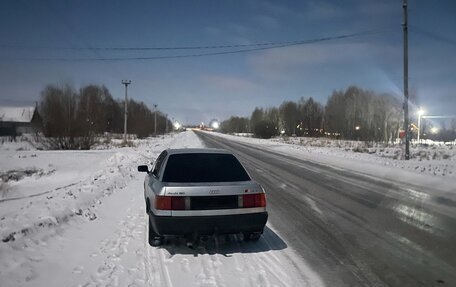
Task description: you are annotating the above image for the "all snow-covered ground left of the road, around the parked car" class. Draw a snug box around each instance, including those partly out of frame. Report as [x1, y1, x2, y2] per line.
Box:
[0, 131, 322, 286]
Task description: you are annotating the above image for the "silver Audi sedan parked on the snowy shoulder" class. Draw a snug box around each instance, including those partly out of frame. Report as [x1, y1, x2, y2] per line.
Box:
[138, 149, 268, 246]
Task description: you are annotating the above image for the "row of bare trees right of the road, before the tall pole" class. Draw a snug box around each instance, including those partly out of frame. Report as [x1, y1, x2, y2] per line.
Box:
[221, 86, 403, 142]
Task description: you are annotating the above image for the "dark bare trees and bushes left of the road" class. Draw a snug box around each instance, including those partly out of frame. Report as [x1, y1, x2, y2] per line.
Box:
[39, 85, 171, 149]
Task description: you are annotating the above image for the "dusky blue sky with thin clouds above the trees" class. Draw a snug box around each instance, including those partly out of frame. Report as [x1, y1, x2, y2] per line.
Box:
[0, 0, 456, 124]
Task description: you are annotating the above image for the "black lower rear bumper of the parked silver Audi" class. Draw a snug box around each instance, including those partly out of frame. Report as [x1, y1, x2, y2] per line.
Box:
[149, 211, 268, 235]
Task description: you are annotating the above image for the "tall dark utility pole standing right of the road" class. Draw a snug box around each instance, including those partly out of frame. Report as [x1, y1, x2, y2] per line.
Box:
[402, 0, 410, 160]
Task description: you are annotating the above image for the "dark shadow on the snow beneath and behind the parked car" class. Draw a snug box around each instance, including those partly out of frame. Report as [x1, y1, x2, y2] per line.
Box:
[159, 226, 288, 257]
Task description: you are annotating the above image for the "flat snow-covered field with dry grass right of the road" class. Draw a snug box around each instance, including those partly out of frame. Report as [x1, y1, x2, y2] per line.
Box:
[207, 133, 456, 192]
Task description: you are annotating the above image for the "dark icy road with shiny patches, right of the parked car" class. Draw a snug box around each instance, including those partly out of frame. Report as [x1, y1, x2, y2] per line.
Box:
[197, 132, 456, 287]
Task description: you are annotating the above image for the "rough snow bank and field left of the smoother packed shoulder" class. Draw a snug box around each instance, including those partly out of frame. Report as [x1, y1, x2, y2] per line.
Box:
[0, 134, 180, 242]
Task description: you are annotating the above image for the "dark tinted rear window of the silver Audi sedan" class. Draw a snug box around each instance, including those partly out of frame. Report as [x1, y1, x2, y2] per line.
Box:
[163, 153, 250, 182]
